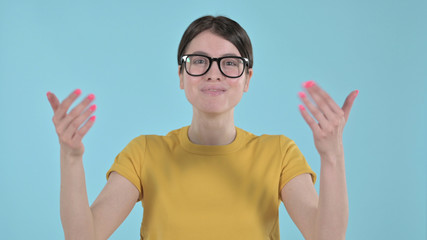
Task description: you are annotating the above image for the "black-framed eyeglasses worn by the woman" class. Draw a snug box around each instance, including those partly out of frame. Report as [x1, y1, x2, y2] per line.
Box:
[181, 54, 249, 78]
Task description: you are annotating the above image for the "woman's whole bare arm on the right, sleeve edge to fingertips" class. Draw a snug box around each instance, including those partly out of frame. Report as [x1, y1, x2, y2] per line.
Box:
[282, 81, 358, 240]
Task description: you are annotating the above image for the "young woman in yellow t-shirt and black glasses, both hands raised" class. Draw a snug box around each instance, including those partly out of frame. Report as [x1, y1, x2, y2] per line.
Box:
[47, 16, 358, 240]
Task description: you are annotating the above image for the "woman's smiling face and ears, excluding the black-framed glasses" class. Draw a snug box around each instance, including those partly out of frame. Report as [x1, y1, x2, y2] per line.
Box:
[178, 30, 252, 113]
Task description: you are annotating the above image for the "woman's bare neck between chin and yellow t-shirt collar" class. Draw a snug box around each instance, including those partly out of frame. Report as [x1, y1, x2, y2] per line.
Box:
[188, 110, 236, 145]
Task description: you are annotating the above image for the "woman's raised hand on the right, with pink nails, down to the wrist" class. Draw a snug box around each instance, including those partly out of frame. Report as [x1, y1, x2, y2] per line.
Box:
[299, 81, 359, 159]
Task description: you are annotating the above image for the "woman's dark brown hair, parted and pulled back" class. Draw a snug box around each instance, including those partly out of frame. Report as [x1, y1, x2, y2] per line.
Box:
[178, 16, 253, 71]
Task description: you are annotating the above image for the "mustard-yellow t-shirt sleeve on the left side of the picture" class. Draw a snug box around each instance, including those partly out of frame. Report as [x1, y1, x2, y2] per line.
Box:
[106, 135, 146, 201]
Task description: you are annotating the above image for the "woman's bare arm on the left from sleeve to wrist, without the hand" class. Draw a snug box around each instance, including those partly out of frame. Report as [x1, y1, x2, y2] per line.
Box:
[60, 155, 139, 240]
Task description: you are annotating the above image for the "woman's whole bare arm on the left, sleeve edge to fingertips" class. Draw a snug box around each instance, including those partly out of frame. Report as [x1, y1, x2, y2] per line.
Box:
[47, 90, 139, 239]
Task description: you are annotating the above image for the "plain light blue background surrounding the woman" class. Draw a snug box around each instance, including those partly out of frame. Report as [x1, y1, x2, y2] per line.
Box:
[0, 0, 427, 239]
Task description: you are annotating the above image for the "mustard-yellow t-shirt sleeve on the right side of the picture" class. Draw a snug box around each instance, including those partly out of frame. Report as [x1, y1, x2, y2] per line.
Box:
[279, 135, 316, 196]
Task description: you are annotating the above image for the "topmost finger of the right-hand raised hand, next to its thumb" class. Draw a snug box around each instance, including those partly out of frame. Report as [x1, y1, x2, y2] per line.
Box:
[304, 81, 343, 121]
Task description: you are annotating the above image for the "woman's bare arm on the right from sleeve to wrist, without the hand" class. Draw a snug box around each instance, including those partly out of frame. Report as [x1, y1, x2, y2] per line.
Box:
[281, 156, 349, 240]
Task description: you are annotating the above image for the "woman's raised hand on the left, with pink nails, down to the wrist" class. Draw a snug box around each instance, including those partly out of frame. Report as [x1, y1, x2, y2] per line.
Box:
[47, 89, 96, 157]
